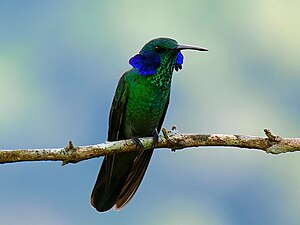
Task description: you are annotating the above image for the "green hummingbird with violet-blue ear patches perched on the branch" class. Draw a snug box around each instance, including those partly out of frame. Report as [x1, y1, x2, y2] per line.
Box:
[91, 38, 208, 212]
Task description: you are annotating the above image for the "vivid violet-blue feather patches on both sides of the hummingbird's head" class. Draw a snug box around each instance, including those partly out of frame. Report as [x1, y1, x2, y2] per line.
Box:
[129, 51, 183, 76]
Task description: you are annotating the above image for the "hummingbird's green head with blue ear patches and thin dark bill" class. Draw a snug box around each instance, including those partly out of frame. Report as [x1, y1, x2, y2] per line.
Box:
[129, 38, 208, 76]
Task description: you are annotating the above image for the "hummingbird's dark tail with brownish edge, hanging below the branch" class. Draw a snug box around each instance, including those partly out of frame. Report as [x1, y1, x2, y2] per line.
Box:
[91, 150, 153, 212]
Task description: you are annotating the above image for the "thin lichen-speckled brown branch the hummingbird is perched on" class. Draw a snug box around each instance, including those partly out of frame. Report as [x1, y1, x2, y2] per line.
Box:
[0, 127, 300, 165]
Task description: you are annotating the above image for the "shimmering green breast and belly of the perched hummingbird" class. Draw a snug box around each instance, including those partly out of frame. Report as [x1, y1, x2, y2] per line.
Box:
[123, 70, 172, 138]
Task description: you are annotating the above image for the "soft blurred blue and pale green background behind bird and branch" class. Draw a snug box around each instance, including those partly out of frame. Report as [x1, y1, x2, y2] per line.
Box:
[0, 0, 300, 225]
